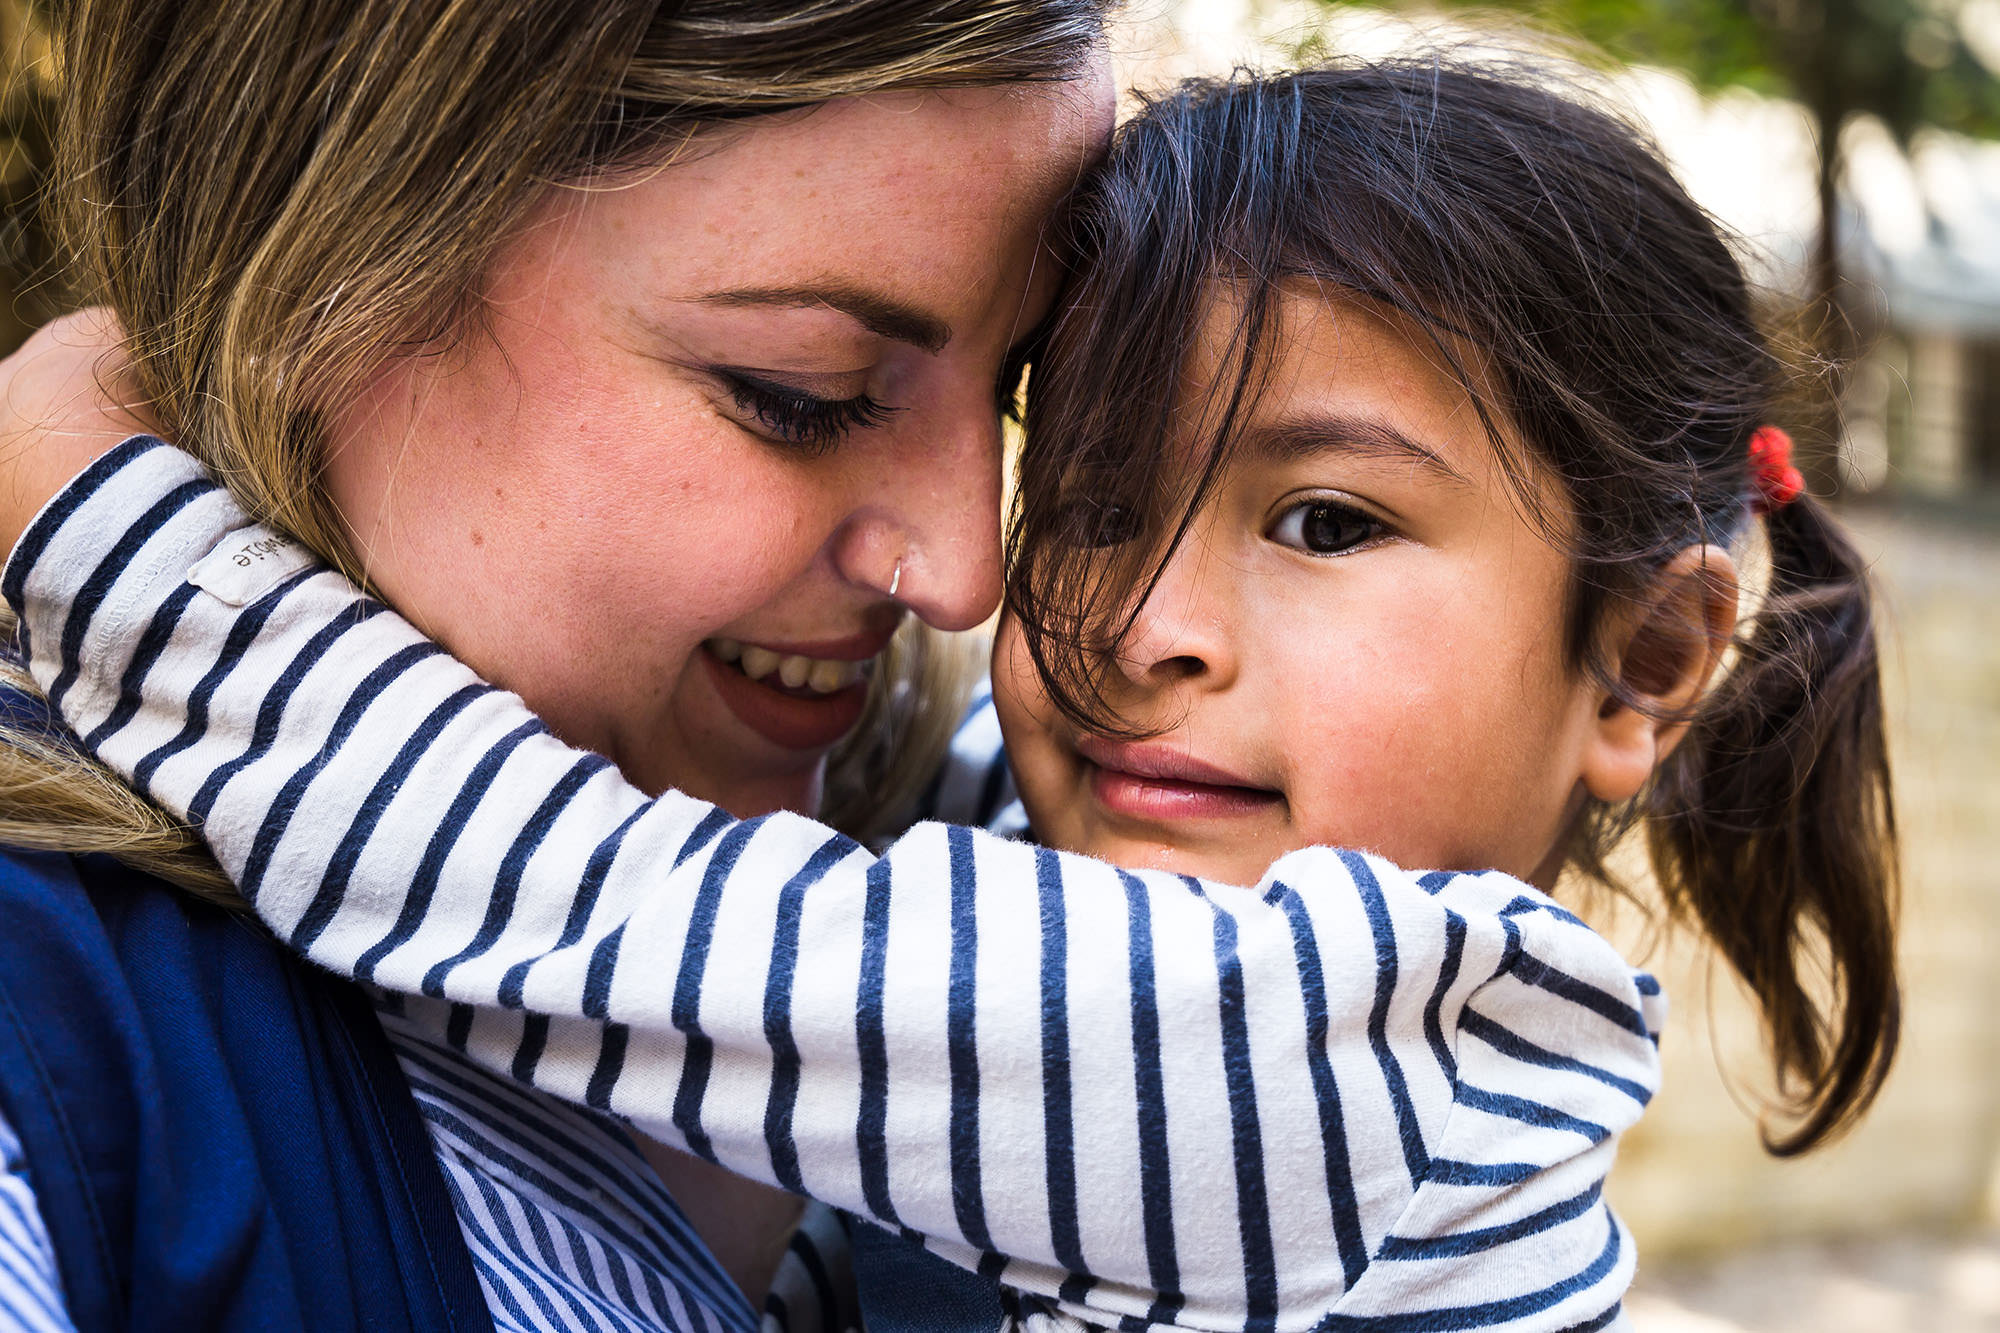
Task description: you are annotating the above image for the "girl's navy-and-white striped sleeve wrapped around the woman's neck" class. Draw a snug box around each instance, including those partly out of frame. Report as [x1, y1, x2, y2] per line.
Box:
[4, 440, 1658, 1333]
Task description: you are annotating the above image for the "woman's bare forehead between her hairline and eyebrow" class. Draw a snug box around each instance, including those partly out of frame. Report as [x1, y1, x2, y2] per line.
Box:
[514, 80, 1108, 324]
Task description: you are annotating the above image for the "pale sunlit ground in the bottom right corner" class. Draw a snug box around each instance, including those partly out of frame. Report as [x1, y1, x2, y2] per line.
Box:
[1626, 1233, 2000, 1333]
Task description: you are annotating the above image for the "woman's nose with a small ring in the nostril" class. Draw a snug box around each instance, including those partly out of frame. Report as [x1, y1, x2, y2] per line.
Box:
[834, 404, 1002, 630]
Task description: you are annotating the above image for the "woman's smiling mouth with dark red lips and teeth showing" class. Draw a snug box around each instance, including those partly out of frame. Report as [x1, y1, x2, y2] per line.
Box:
[700, 634, 888, 751]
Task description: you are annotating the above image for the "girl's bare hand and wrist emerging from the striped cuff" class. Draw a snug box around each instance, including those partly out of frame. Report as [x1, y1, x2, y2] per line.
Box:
[0, 306, 154, 550]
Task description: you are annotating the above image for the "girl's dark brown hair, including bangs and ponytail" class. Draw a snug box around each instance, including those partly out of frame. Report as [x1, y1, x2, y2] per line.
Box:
[1008, 58, 1898, 1155]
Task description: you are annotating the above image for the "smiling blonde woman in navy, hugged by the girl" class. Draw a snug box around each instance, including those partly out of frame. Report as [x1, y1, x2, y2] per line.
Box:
[6, 0, 1110, 1329]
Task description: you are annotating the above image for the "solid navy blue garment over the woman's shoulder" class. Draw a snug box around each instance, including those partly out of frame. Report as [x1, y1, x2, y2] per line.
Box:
[0, 849, 482, 1333]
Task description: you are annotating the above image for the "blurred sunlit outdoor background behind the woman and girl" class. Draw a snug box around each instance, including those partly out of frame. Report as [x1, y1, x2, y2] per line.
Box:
[0, 0, 2000, 1333]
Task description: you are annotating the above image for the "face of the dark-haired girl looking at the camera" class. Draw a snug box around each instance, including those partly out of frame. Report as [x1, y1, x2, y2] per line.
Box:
[994, 294, 1606, 883]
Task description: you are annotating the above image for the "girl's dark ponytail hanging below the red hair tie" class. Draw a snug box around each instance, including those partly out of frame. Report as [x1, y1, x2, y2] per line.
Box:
[1648, 496, 1900, 1157]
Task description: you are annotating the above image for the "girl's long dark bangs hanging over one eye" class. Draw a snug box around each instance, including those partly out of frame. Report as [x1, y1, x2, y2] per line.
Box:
[1008, 84, 1296, 735]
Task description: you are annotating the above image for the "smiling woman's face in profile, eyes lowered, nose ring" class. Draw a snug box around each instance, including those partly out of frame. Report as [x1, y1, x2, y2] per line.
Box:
[328, 68, 1112, 815]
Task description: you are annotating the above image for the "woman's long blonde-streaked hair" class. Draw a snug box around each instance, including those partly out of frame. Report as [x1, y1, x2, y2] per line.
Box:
[0, 0, 1110, 903]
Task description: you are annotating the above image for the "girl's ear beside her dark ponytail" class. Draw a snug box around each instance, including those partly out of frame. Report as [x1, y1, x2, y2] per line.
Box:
[1582, 546, 1736, 805]
